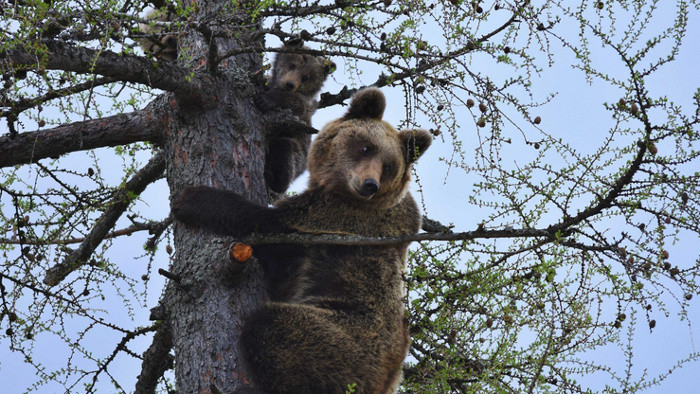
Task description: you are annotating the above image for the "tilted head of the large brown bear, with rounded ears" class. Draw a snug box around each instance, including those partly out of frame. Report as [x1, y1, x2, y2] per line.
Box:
[308, 88, 432, 209]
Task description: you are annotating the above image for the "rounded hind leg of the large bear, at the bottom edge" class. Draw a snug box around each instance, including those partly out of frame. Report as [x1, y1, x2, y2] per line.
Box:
[241, 303, 371, 393]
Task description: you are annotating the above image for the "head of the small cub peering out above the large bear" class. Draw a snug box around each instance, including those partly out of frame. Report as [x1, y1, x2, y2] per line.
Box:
[272, 44, 335, 97]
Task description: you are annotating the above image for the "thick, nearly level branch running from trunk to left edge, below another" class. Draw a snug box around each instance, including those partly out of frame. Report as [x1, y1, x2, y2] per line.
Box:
[0, 111, 161, 168]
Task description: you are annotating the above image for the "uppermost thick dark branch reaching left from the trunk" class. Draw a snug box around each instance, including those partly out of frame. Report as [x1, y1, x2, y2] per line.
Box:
[3, 40, 199, 96]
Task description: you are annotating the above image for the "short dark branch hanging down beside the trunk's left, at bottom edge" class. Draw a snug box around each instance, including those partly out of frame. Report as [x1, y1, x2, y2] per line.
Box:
[134, 321, 173, 394]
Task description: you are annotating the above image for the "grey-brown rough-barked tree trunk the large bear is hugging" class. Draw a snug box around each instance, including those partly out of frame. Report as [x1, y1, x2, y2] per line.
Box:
[162, 1, 267, 393]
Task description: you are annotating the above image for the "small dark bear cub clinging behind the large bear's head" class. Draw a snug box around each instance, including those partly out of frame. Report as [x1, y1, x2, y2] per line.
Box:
[255, 42, 335, 193]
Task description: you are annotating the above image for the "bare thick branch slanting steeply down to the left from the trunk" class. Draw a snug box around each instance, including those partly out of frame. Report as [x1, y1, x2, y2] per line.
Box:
[44, 152, 165, 286]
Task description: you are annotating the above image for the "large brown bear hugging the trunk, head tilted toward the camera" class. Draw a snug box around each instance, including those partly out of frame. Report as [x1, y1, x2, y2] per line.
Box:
[172, 88, 431, 393]
